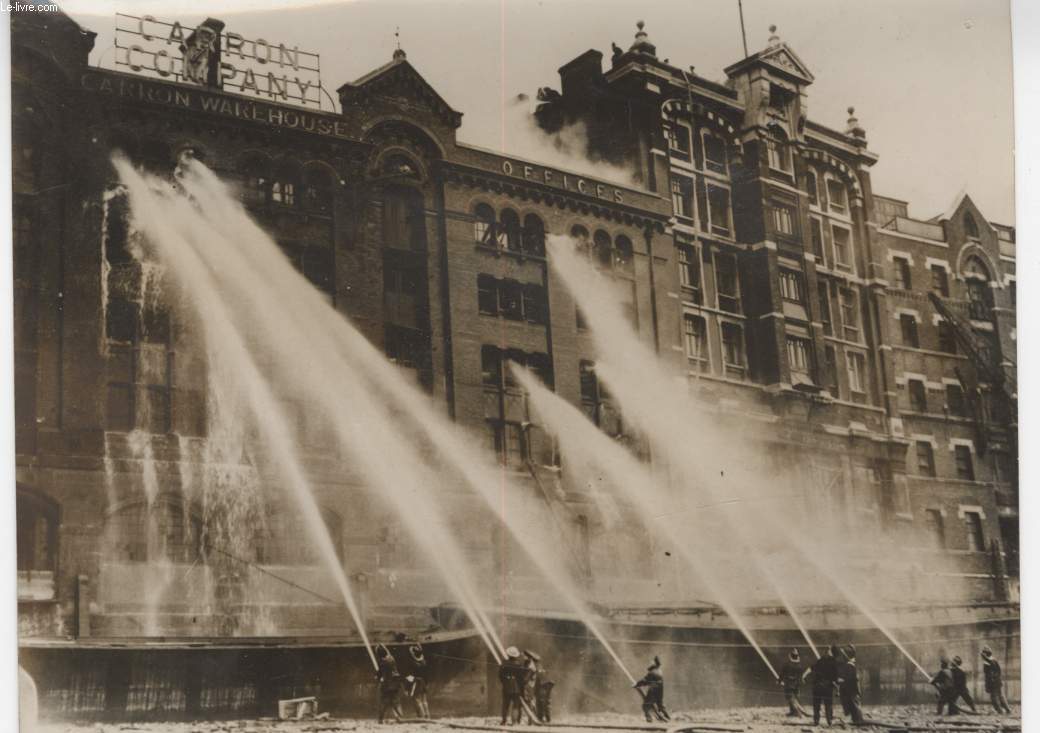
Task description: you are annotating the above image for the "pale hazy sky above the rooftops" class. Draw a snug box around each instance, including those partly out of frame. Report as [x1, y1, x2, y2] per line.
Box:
[62, 0, 1014, 224]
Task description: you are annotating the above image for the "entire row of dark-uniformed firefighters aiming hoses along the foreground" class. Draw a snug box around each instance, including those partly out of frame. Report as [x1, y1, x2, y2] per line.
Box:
[376, 644, 1011, 726]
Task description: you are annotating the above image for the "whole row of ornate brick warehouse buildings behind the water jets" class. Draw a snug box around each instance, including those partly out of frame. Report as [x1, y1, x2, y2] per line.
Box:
[12, 5, 1018, 717]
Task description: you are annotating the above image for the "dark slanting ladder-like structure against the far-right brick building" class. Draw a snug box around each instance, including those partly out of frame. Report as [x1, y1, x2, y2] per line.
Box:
[928, 292, 1018, 455]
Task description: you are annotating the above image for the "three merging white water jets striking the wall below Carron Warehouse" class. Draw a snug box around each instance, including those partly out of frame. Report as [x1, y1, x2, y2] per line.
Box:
[116, 156, 631, 679]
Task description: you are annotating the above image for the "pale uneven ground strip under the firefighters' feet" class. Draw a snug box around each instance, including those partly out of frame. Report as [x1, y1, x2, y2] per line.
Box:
[28, 705, 1021, 733]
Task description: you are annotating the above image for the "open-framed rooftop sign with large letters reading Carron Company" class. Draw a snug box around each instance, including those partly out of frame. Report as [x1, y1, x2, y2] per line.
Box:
[115, 14, 324, 108]
